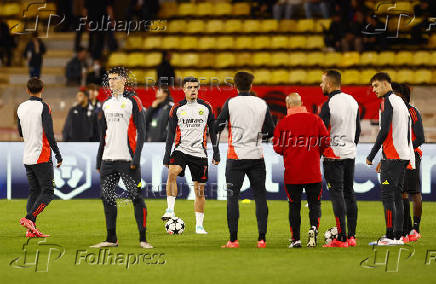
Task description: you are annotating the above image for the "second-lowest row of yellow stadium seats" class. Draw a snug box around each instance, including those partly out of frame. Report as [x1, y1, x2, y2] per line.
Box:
[108, 51, 436, 68]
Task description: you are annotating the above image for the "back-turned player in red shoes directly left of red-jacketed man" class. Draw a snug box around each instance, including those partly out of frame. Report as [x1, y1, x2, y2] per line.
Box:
[215, 72, 274, 248]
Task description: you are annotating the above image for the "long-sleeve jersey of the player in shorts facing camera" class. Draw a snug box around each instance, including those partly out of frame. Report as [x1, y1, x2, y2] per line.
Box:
[163, 99, 220, 165]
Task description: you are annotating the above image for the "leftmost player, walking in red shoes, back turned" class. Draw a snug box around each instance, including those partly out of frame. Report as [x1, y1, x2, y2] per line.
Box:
[17, 78, 62, 238]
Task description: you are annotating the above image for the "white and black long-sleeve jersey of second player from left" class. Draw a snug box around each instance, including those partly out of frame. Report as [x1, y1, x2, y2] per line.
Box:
[97, 91, 145, 169]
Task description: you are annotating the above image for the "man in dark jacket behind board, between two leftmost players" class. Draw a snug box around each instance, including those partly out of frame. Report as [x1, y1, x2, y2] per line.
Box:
[62, 91, 97, 142]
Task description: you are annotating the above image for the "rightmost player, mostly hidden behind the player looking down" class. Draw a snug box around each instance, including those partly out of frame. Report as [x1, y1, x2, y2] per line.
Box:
[392, 83, 425, 242]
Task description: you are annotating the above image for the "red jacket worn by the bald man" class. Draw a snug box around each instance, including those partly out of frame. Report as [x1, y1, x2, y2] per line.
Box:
[273, 108, 330, 184]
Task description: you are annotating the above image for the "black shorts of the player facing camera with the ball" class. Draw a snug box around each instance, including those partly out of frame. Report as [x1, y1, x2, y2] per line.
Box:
[170, 151, 208, 183]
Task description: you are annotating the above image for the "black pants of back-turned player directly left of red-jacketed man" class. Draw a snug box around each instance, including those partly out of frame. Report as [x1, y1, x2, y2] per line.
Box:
[226, 159, 268, 241]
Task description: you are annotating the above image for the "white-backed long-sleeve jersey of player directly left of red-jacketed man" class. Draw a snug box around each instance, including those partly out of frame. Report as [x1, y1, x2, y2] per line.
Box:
[215, 92, 274, 160]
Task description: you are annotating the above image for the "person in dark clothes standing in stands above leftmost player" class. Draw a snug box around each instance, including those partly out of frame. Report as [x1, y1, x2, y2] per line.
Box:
[23, 32, 46, 78]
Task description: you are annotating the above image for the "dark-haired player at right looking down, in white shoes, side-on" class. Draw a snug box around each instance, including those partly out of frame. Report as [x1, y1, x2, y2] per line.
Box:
[366, 72, 415, 246]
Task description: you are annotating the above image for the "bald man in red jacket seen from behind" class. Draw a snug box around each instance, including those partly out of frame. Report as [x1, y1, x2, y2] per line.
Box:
[273, 93, 330, 248]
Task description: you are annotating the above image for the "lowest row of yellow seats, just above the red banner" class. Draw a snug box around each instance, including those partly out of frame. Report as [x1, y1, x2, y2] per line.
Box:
[132, 69, 436, 85]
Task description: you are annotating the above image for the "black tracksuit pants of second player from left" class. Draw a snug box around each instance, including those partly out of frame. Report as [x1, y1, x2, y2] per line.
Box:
[100, 160, 147, 242]
